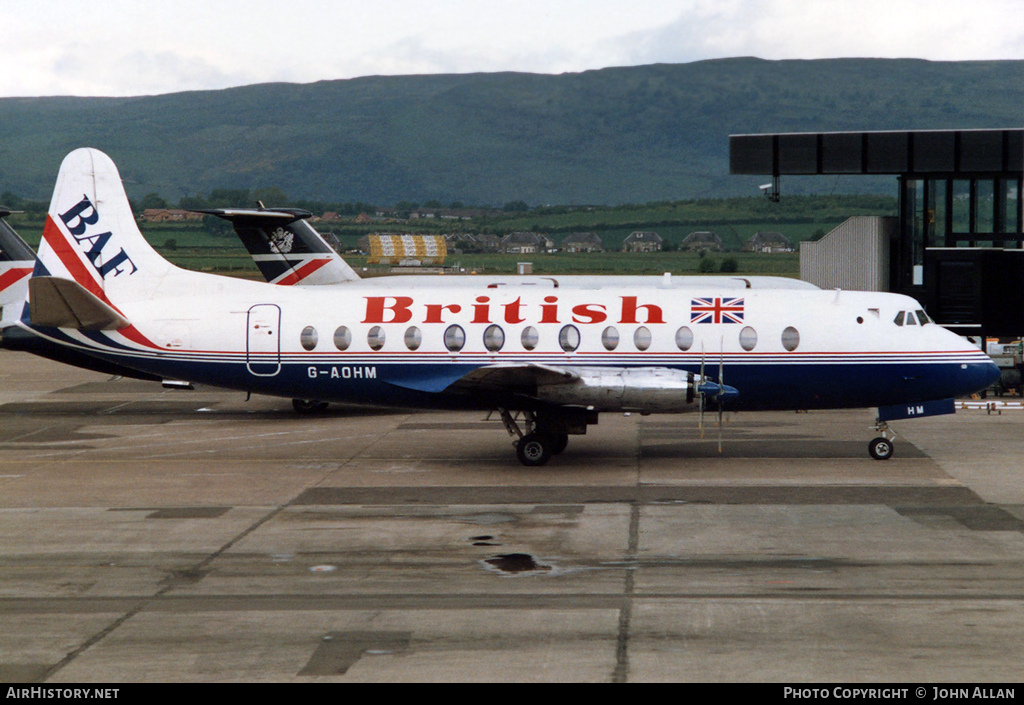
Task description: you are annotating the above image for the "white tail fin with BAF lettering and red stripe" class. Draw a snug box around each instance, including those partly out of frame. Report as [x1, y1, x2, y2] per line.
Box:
[34, 149, 180, 305]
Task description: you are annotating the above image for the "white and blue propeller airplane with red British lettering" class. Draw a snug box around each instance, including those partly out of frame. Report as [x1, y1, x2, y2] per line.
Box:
[4, 149, 999, 466]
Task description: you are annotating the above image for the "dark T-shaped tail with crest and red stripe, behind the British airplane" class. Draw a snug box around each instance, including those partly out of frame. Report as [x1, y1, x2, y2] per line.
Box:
[198, 206, 359, 286]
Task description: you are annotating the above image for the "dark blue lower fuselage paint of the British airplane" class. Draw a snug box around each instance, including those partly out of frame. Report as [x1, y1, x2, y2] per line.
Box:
[61, 346, 999, 411]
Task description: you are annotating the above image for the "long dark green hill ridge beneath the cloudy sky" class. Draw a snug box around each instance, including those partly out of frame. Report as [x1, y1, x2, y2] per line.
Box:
[0, 58, 1024, 205]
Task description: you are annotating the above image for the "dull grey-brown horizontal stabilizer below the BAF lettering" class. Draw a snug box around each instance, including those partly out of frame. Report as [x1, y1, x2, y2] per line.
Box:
[29, 277, 131, 330]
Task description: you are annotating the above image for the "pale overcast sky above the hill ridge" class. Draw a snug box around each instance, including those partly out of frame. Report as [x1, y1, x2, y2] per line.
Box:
[0, 0, 1024, 96]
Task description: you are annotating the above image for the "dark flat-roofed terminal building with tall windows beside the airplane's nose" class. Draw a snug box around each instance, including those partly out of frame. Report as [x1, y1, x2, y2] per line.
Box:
[729, 129, 1024, 338]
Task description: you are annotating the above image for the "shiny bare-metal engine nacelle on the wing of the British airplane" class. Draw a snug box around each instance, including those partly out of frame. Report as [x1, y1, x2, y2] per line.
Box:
[537, 367, 700, 414]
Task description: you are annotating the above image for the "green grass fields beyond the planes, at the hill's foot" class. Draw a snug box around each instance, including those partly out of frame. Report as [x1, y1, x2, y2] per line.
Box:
[9, 196, 896, 279]
